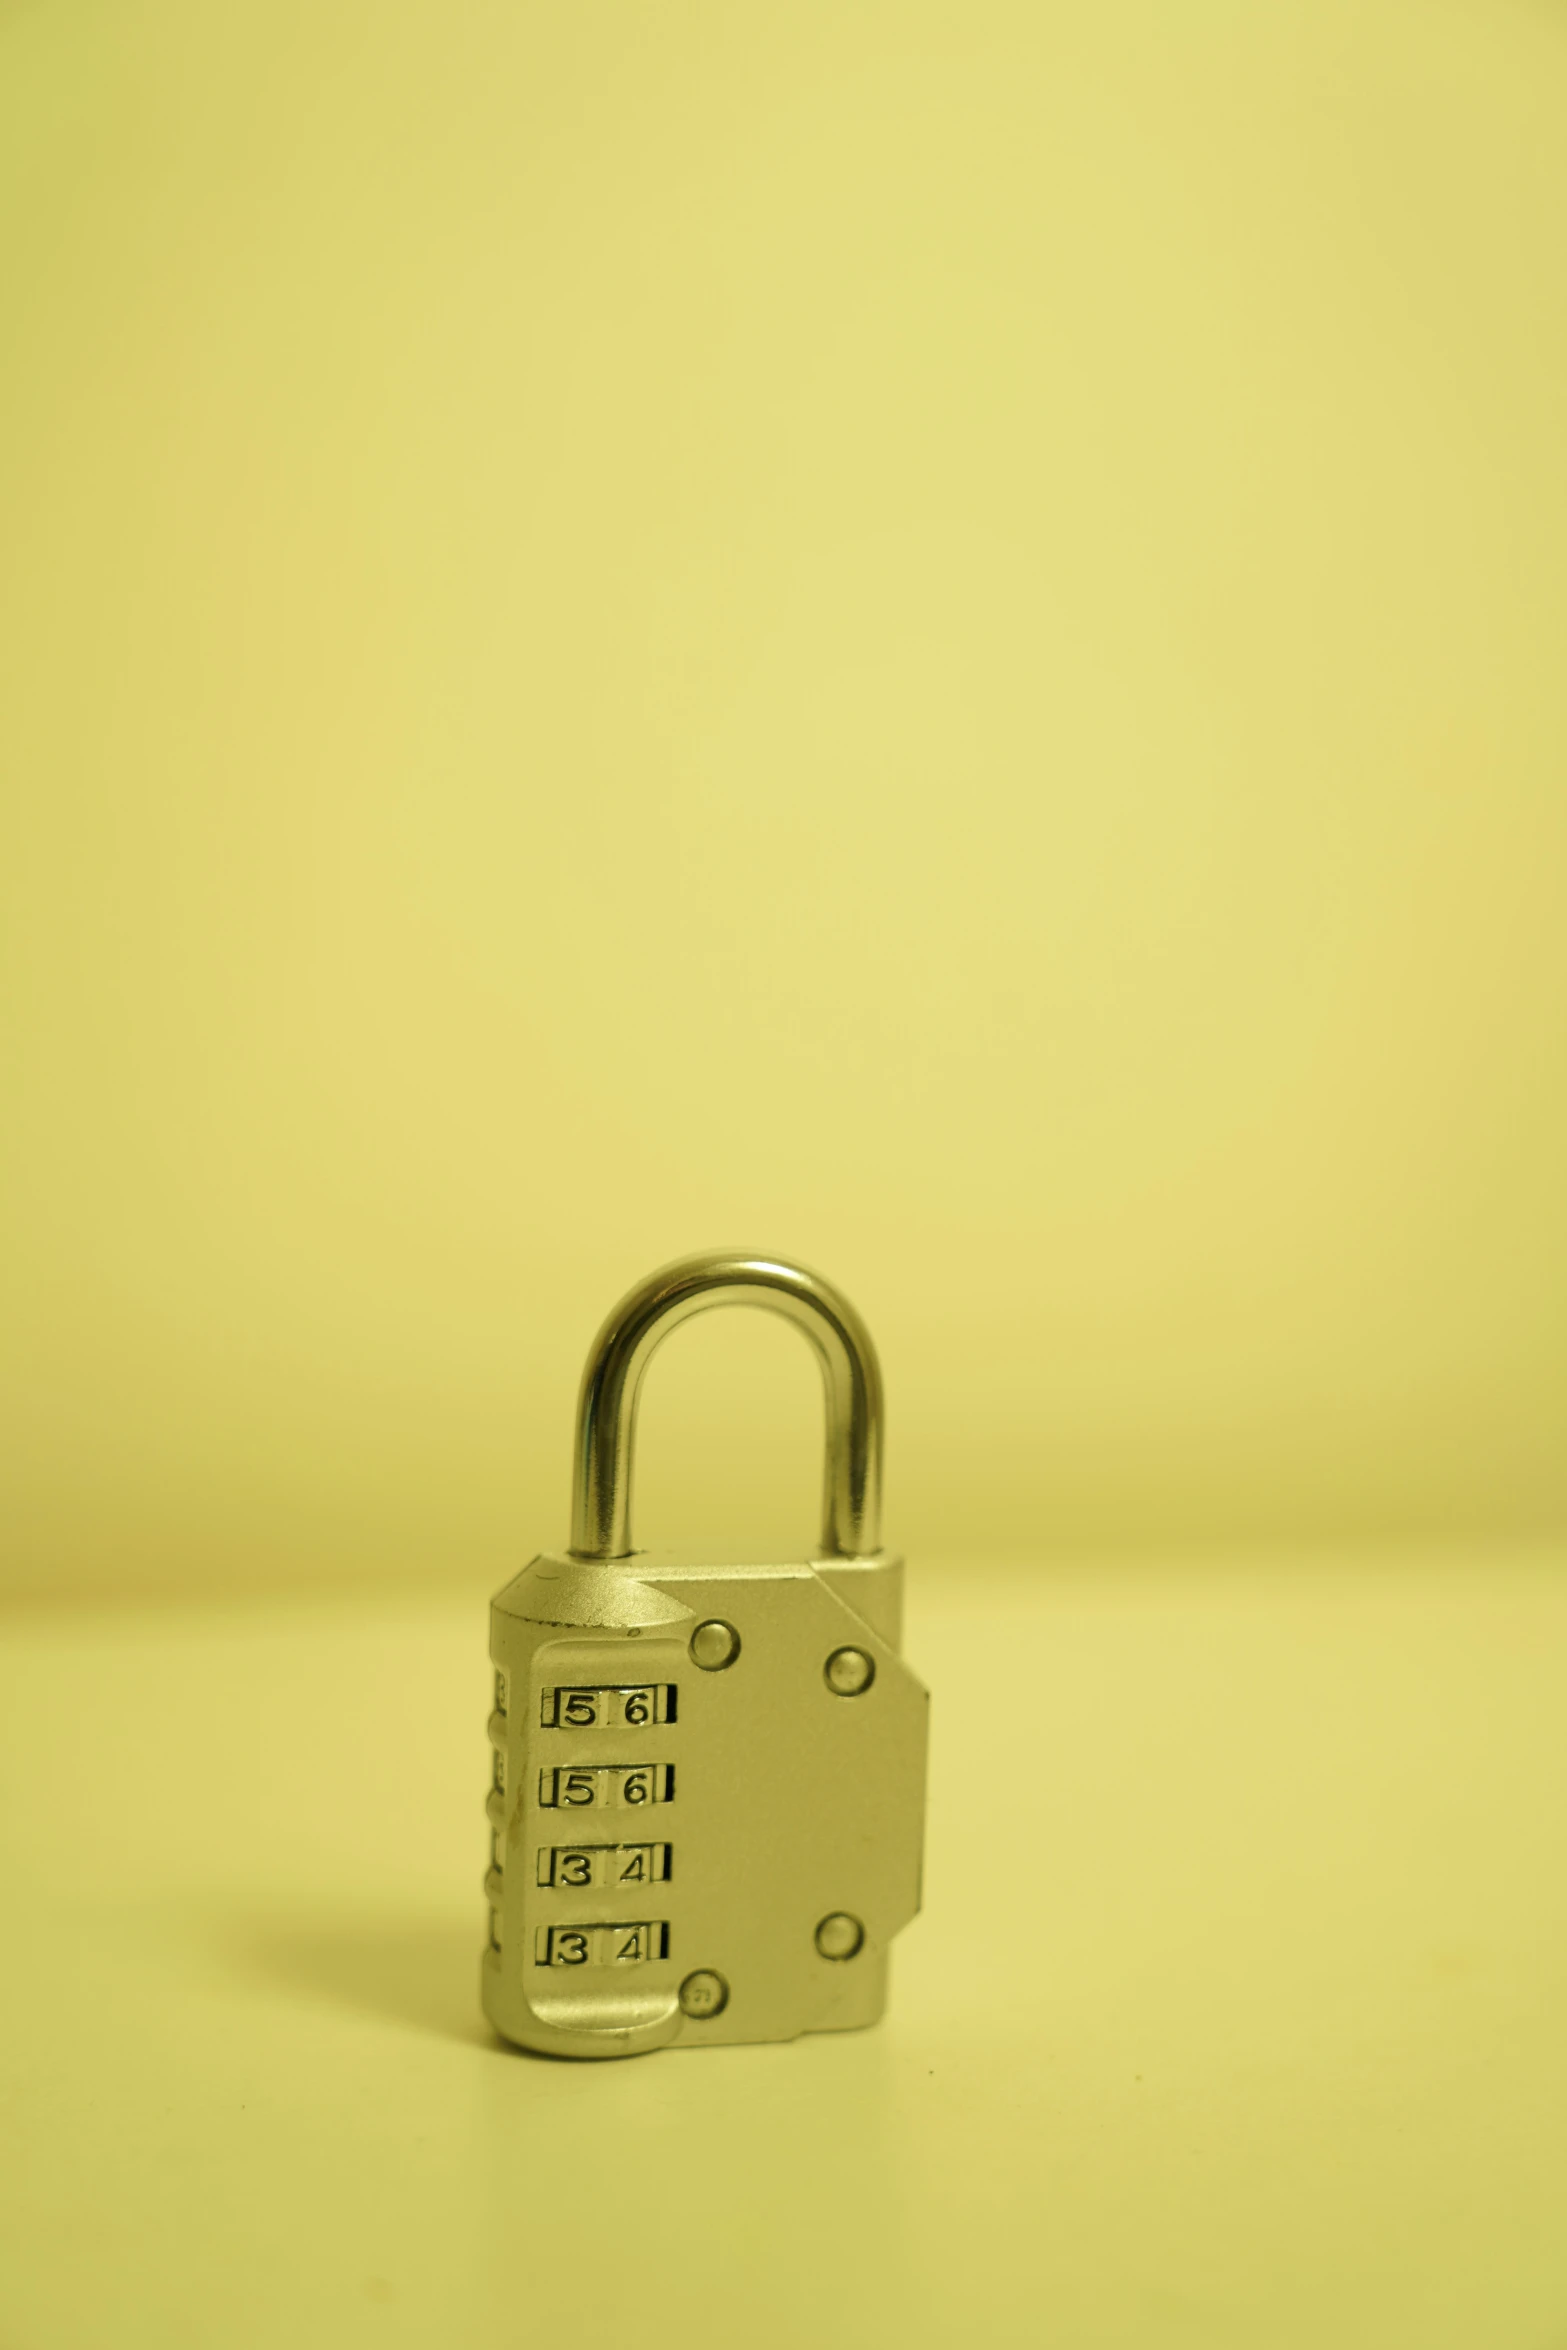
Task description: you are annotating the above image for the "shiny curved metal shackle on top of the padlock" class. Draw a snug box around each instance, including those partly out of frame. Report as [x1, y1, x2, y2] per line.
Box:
[571, 1248, 881, 1558]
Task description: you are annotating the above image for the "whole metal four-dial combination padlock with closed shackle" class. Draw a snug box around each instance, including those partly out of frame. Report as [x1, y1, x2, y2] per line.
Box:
[482, 1250, 928, 2056]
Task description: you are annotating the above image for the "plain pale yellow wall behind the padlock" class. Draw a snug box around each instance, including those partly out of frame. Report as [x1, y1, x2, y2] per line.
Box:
[0, 0, 1567, 1591]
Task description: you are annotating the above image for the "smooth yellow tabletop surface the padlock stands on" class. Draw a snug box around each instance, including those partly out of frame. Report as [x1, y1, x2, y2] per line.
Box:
[0, 1549, 1567, 2350]
